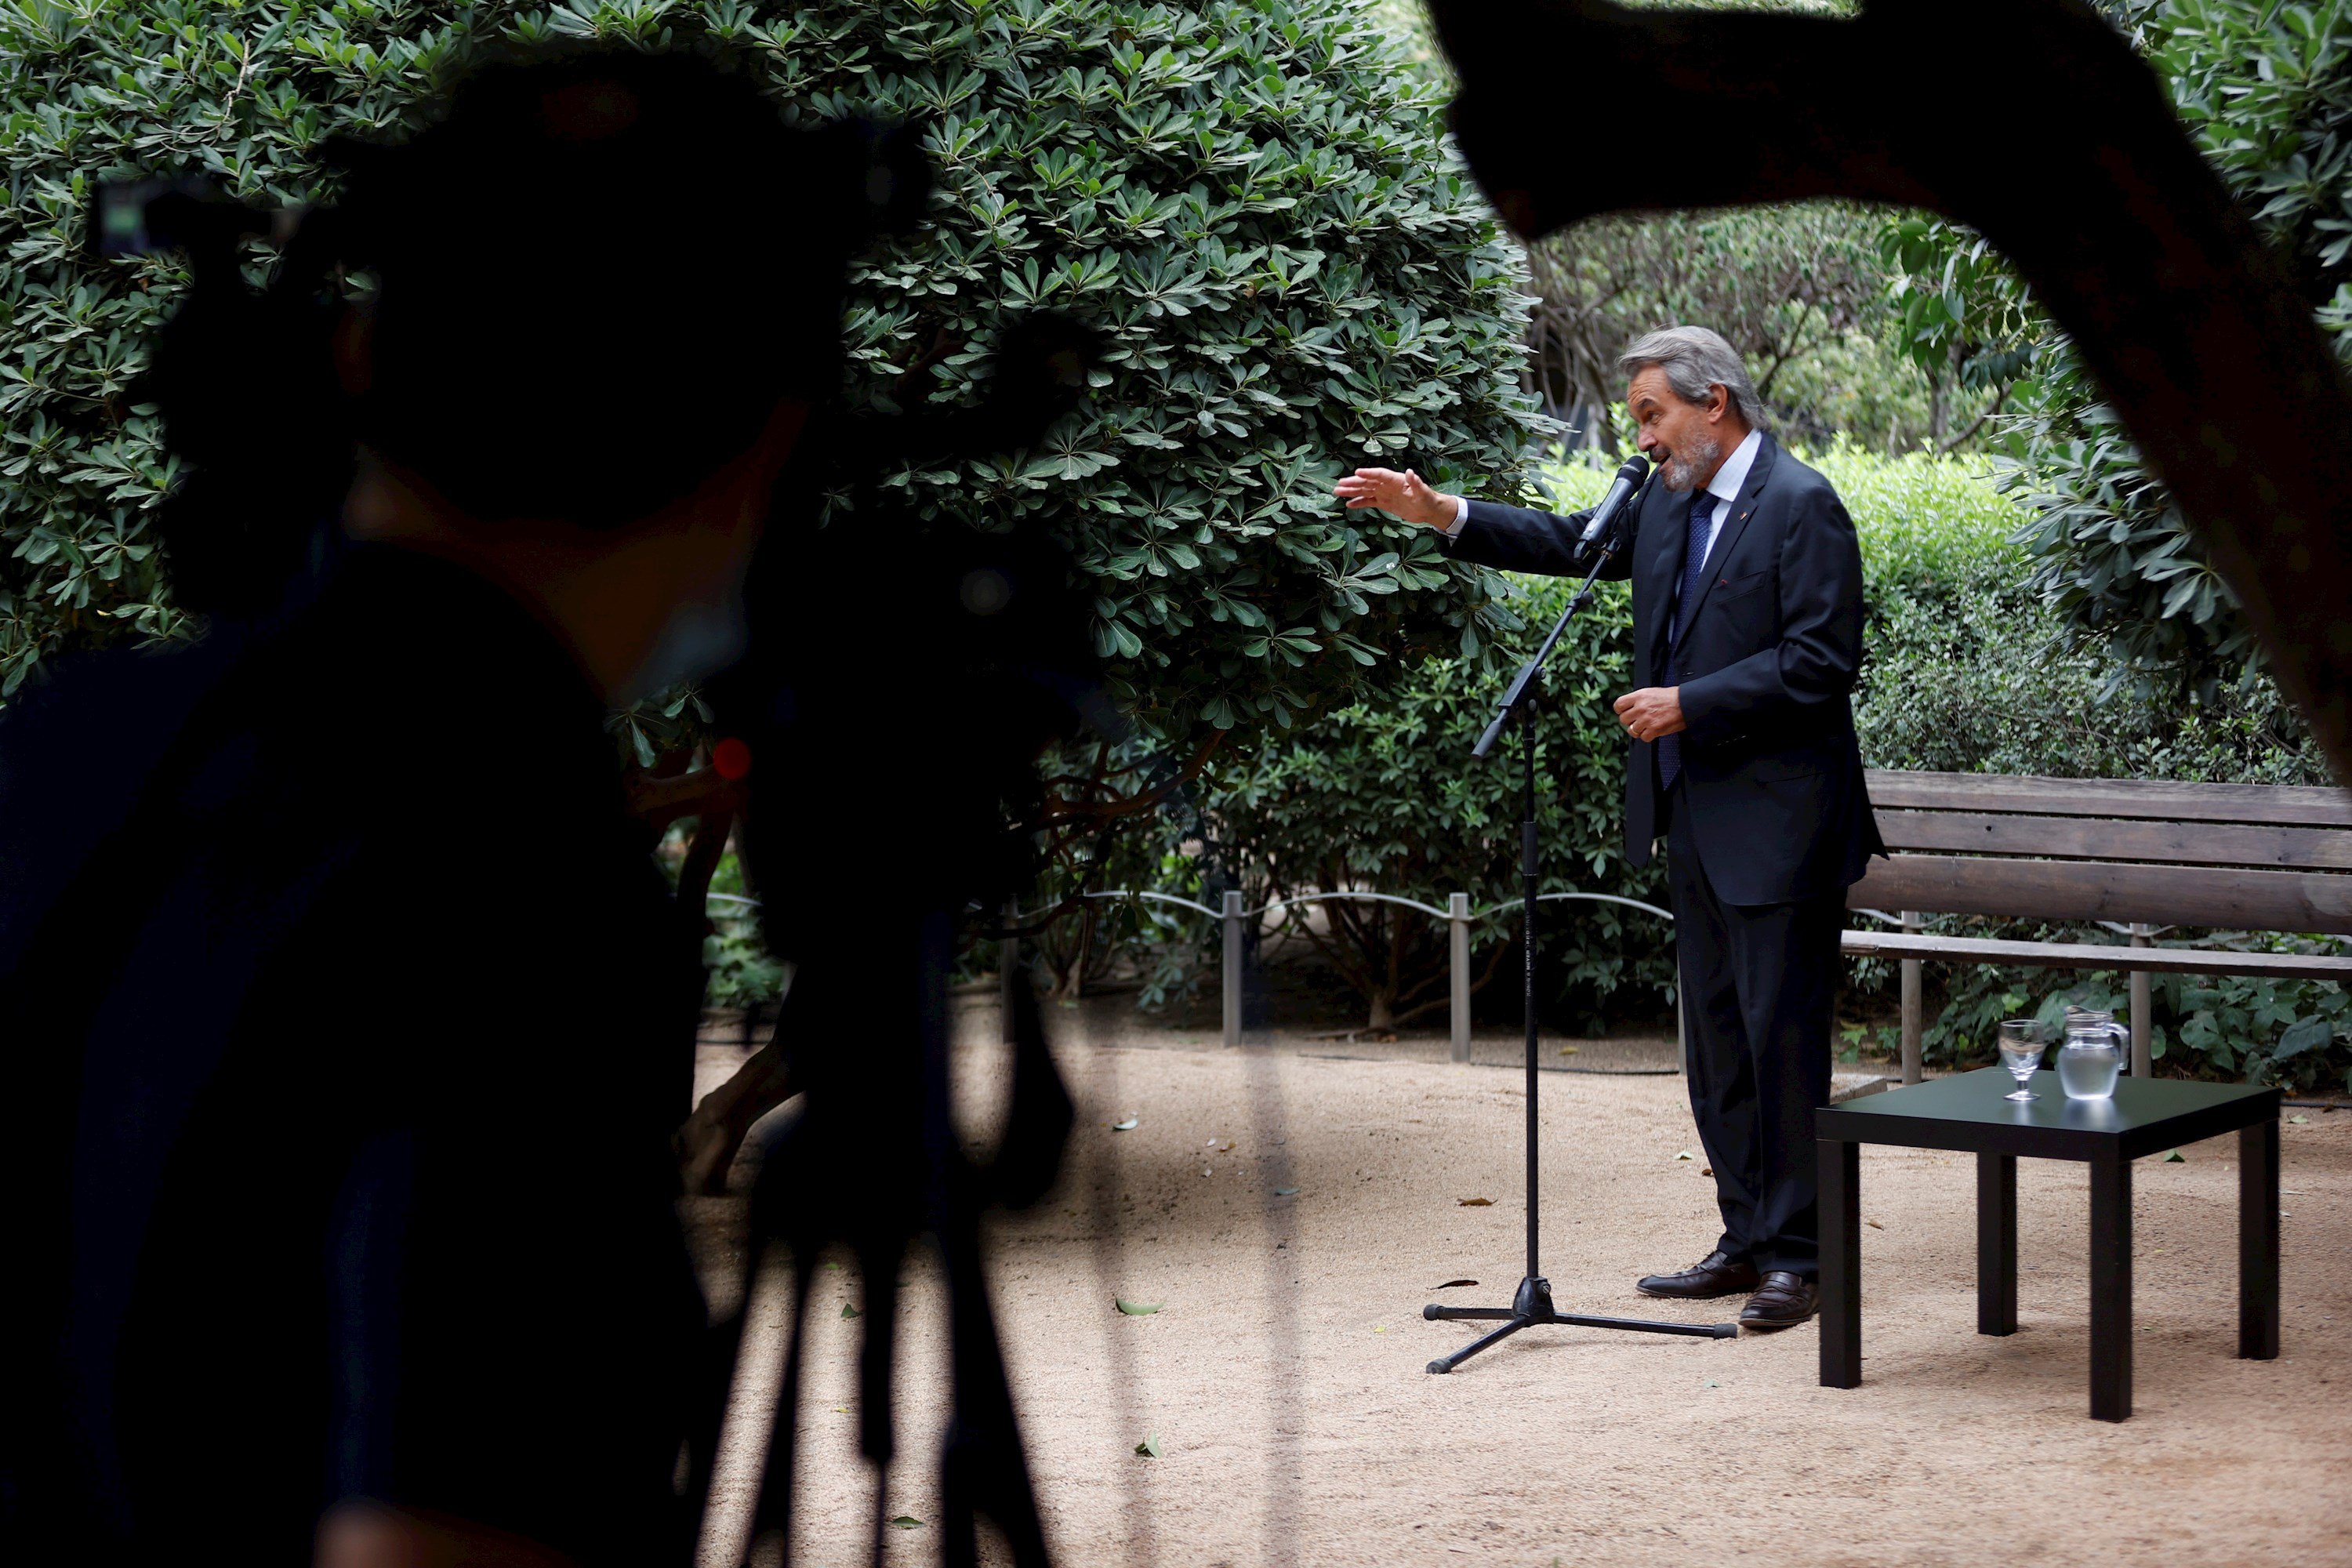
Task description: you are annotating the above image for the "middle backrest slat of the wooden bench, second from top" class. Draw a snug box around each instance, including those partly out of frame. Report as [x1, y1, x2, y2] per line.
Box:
[1877, 806, 2352, 869]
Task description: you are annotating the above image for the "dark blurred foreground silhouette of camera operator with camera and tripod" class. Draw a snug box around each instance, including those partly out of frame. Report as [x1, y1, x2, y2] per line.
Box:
[0, 42, 1089, 1568]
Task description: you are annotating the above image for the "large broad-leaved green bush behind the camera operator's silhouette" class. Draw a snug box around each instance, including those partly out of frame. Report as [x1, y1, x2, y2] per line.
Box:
[0, 0, 1538, 741]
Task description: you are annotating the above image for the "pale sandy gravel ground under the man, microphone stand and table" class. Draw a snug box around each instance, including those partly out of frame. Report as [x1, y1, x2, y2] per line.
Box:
[689, 996, 2352, 1568]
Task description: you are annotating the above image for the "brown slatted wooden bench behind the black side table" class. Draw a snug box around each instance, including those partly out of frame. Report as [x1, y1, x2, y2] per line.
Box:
[1844, 771, 2352, 1083]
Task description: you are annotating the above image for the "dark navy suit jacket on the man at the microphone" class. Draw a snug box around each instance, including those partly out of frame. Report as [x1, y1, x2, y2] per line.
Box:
[1454, 435, 1886, 905]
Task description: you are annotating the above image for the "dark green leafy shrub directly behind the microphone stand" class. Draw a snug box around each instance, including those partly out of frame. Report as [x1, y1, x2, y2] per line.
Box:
[1202, 557, 1675, 1029]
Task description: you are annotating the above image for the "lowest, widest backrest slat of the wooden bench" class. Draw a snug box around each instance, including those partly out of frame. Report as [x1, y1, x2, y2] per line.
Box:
[1846, 853, 2352, 935]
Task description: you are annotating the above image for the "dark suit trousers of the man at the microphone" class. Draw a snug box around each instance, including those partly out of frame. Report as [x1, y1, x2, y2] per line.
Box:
[1665, 781, 1846, 1279]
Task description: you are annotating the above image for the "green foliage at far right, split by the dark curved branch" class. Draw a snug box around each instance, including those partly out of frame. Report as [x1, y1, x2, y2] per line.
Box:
[1886, 0, 2352, 701]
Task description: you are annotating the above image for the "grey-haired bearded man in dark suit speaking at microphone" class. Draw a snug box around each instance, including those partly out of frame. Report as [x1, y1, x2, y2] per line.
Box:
[1338, 327, 1884, 1328]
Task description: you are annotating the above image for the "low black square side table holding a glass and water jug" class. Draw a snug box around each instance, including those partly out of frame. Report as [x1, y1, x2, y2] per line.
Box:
[1813, 1067, 2279, 1420]
